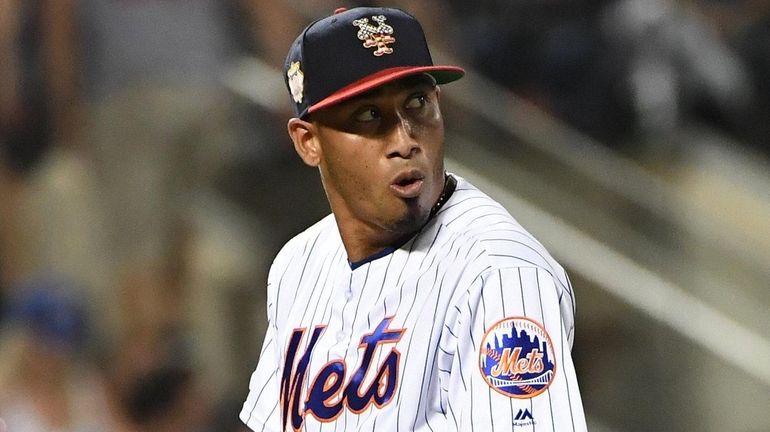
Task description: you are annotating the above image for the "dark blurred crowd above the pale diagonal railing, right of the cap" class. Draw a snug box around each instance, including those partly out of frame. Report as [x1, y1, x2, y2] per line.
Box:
[440, 0, 770, 157]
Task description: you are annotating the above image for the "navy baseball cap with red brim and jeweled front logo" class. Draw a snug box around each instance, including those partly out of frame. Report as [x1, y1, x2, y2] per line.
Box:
[284, 7, 465, 118]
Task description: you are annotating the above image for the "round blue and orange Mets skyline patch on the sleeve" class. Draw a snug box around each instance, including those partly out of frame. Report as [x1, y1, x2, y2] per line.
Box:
[479, 317, 556, 399]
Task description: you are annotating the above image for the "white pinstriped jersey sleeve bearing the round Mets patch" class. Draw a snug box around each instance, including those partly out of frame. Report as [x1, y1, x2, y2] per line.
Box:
[445, 267, 586, 432]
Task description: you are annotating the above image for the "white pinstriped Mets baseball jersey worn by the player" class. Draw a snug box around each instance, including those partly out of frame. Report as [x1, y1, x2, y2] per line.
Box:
[240, 176, 586, 432]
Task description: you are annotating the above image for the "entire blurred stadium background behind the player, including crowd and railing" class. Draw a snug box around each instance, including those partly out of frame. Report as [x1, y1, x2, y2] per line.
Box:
[0, 0, 770, 432]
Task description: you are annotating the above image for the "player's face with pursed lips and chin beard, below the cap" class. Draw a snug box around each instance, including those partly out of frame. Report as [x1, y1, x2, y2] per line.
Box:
[312, 75, 444, 241]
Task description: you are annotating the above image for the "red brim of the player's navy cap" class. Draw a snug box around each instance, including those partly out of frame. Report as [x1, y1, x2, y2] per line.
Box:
[307, 66, 465, 114]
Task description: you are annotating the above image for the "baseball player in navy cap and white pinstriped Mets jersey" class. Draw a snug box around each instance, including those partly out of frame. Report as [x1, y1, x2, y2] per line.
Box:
[240, 8, 586, 432]
